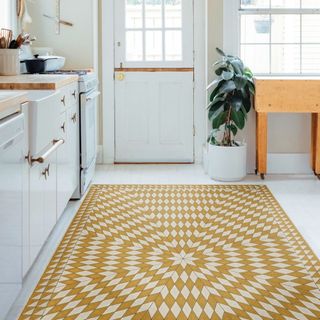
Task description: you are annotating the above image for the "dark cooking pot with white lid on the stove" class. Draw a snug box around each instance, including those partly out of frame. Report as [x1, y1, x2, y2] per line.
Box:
[21, 55, 65, 73]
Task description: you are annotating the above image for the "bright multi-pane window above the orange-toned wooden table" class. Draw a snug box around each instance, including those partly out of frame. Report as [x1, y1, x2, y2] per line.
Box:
[239, 0, 320, 75]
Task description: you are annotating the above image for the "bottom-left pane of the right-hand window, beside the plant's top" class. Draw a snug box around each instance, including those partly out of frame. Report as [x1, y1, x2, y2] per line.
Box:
[241, 44, 270, 73]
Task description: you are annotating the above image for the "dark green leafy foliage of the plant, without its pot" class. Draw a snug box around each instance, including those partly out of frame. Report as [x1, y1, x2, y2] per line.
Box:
[208, 48, 255, 147]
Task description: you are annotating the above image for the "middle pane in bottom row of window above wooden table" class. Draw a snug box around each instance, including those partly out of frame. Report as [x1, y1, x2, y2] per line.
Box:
[271, 44, 300, 73]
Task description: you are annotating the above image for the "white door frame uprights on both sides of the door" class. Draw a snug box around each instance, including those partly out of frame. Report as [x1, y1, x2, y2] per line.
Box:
[100, 0, 207, 164]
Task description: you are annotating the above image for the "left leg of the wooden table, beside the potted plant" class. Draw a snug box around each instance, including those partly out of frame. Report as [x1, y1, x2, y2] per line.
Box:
[257, 112, 268, 178]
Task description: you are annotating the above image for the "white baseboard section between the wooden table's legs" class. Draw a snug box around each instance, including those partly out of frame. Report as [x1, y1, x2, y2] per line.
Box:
[268, 153, 312, 174]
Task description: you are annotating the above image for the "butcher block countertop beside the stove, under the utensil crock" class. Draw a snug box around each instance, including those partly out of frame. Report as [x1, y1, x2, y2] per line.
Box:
[0, 74, 78, 90]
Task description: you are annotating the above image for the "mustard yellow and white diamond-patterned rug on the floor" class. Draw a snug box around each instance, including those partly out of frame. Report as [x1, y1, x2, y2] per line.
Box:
[20, 185, 320, 320]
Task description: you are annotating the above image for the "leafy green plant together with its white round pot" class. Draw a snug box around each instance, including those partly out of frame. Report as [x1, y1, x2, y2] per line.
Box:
[208, 48, 255, 181]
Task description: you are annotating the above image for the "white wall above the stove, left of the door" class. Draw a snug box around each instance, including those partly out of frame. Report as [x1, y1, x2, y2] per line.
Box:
[27, 0, 98, 69]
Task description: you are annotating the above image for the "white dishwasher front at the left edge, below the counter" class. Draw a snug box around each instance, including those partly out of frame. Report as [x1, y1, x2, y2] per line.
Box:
[0, 113, 25, 319]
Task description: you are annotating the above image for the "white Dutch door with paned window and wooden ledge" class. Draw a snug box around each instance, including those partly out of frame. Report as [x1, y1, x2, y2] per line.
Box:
[115, 0, 194, 163]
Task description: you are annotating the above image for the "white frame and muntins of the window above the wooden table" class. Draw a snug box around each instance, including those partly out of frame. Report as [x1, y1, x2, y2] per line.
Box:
[224, 0, 320, 77]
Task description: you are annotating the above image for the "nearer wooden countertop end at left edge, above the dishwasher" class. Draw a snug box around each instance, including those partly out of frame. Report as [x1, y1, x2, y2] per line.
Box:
[0, 91, 28, 119]
